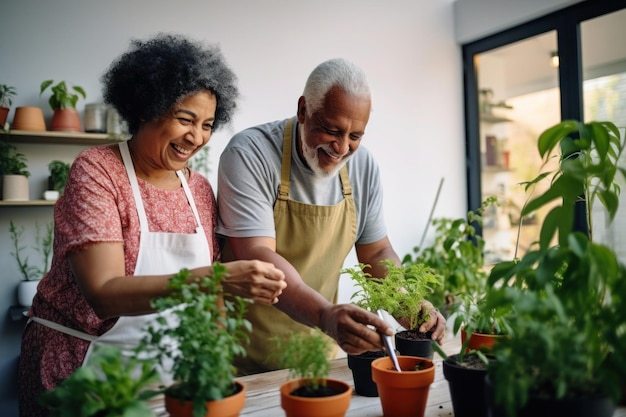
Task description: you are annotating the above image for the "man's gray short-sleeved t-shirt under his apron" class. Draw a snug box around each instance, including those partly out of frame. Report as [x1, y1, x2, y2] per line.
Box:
[216, 119, 387, 244]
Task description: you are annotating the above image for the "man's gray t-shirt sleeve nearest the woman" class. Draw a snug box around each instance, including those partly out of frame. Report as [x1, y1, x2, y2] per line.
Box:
[217, 143, 277, 238]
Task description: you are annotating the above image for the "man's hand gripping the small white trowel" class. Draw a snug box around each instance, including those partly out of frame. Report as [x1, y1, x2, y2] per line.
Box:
[319, 304, 394, 355]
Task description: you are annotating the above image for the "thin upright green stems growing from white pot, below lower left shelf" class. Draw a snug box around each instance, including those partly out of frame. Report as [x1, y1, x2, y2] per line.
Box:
[9, 220, 54, 281]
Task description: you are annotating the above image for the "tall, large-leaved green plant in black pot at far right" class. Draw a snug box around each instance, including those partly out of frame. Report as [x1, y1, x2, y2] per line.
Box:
[486, 120, 626, 417]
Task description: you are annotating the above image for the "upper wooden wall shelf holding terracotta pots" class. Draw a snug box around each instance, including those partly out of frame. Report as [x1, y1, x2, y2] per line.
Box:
[0, 130, 128, 145]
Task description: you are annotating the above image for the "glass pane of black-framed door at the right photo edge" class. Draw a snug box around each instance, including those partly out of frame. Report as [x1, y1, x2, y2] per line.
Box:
[580, 10, 626, 262]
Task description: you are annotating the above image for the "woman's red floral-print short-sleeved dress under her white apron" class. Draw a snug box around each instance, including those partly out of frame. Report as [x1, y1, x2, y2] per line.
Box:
[19, 145, 219, 408]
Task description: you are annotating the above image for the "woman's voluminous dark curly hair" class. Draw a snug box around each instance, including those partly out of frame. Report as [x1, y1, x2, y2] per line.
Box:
[102, 34, 239, 134]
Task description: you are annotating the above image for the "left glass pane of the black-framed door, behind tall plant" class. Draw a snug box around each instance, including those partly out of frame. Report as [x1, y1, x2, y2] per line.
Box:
[475, 31, 561, 265]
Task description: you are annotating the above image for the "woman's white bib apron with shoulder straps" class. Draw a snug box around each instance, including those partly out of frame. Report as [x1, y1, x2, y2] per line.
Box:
[32, 142, 212, 385]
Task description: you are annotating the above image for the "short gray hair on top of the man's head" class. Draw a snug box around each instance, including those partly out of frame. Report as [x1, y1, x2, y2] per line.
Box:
[302, 58, 371, 115]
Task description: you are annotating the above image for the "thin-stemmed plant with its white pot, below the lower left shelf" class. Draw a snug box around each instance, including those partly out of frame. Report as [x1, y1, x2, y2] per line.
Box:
[9, 220, 54, 307]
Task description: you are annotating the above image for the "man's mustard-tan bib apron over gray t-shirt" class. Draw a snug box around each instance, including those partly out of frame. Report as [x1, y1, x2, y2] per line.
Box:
[235, 118, 356, 375]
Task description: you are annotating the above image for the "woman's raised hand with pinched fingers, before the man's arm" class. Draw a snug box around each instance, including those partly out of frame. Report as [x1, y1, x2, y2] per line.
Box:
[222, 260, 287, 305]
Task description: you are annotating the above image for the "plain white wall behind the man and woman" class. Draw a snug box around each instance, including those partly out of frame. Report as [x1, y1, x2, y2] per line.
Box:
[0, 0, 466, 415]
